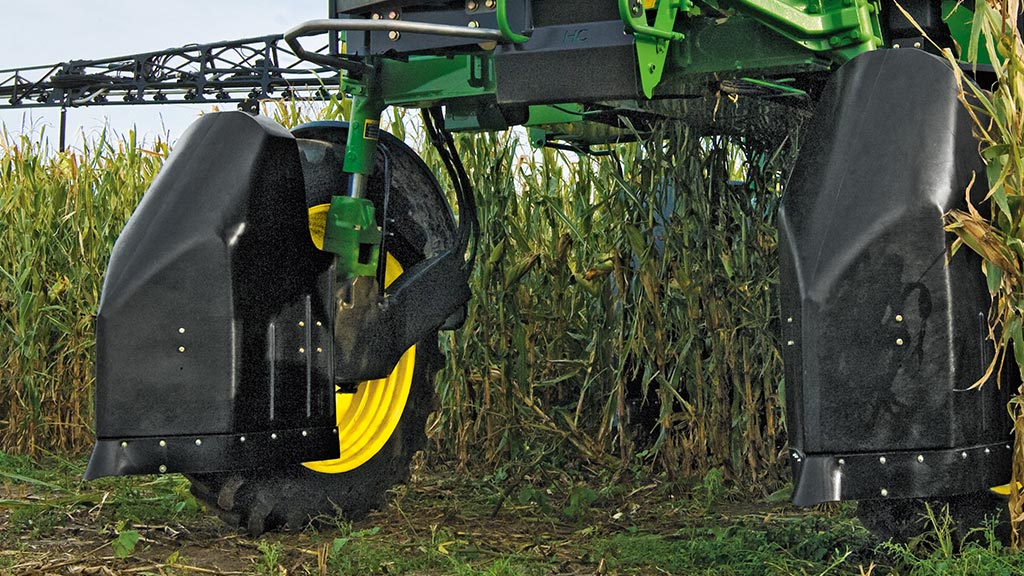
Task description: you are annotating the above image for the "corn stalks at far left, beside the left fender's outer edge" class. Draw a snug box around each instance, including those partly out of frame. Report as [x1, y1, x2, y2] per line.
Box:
[0, 132, 167, 453]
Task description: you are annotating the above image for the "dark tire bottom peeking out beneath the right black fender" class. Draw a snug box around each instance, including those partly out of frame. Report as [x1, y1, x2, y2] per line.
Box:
[857, 491, 1010, 546]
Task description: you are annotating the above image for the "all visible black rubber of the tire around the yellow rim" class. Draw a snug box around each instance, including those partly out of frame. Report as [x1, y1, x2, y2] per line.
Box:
[188, 122, 455, 535]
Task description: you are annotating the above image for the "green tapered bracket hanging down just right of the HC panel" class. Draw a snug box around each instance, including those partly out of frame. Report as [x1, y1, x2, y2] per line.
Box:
[618, 0, 693, 98]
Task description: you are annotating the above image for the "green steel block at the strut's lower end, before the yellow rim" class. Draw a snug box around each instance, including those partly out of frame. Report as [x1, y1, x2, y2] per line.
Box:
[324, 196, 381, 280]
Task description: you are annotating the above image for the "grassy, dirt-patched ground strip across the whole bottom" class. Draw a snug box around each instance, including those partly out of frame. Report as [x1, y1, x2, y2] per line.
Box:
[0, 448, 1024, 576]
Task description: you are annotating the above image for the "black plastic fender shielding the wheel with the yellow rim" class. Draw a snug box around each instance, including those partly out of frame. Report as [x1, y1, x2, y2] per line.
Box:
[86, 112, 455, 479]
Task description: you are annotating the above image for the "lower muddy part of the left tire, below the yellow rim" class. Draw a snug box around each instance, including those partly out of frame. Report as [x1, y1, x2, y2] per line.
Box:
[188, 339, 440, 536]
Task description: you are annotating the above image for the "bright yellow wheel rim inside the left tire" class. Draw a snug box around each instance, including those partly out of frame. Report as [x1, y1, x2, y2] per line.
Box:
[303, 254, 416, 474]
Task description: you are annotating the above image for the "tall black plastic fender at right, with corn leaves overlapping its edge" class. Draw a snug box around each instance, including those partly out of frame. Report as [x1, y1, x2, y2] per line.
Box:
[779, 50, 1016, 505]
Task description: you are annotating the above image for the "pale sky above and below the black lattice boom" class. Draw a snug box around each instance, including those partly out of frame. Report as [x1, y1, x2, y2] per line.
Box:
[0, 0, 328, 148]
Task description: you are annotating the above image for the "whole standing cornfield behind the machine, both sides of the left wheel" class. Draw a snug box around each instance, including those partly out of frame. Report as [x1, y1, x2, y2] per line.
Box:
[0, 97, 800, 487]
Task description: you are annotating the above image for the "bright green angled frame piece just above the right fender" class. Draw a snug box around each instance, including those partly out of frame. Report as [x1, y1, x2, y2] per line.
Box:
[723, 0, 883, 61]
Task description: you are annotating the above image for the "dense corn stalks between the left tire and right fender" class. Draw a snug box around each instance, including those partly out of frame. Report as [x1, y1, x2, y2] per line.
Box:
[427, 118, 797, 485]
